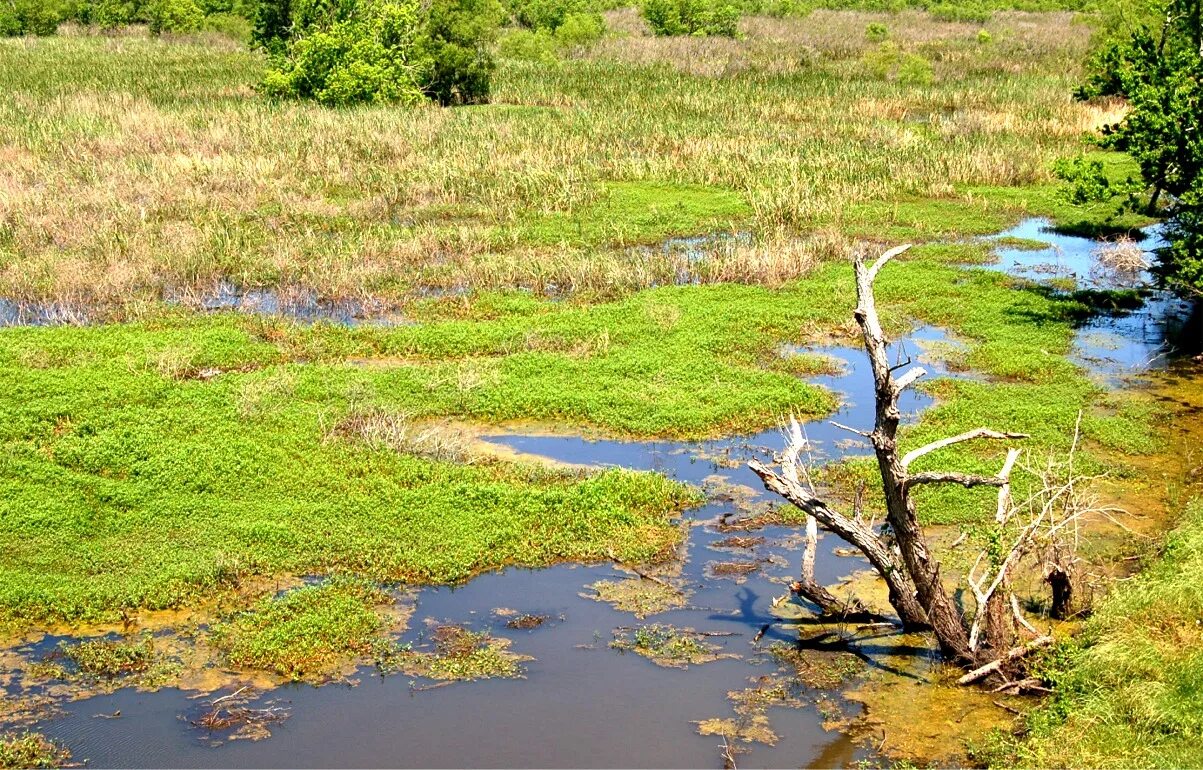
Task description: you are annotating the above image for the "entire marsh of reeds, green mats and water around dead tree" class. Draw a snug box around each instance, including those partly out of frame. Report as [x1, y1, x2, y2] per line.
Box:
[0, 8, 1203, 766]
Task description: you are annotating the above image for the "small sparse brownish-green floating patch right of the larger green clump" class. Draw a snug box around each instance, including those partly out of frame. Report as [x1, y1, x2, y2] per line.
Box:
[387, 624, 532, 681]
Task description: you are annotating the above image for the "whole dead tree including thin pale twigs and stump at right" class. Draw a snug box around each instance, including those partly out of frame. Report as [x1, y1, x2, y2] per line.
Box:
[748, 247, 1106, 682]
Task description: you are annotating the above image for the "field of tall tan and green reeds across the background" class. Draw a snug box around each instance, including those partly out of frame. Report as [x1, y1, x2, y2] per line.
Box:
[0, 10, 1101, 316]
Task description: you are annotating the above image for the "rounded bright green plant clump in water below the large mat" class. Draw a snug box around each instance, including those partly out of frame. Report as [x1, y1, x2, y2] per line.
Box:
[213, 578, 397, 680]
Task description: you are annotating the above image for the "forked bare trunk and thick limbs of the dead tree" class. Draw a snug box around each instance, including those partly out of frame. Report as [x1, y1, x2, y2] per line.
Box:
[748, 247, 1073, 665]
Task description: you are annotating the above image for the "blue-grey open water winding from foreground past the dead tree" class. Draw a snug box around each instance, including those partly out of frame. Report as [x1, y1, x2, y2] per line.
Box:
[4, 220, 1201, 768]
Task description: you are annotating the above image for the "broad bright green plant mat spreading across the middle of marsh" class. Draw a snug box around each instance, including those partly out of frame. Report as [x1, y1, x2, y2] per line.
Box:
[0, 257, 1151, 622]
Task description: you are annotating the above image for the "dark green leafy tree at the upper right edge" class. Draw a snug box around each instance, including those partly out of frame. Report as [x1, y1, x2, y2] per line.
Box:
[1079, 0, 1203, 294]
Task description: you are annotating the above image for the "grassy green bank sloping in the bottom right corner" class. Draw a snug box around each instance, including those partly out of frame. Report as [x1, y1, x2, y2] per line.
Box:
[1001, 501, 1203, 768]
